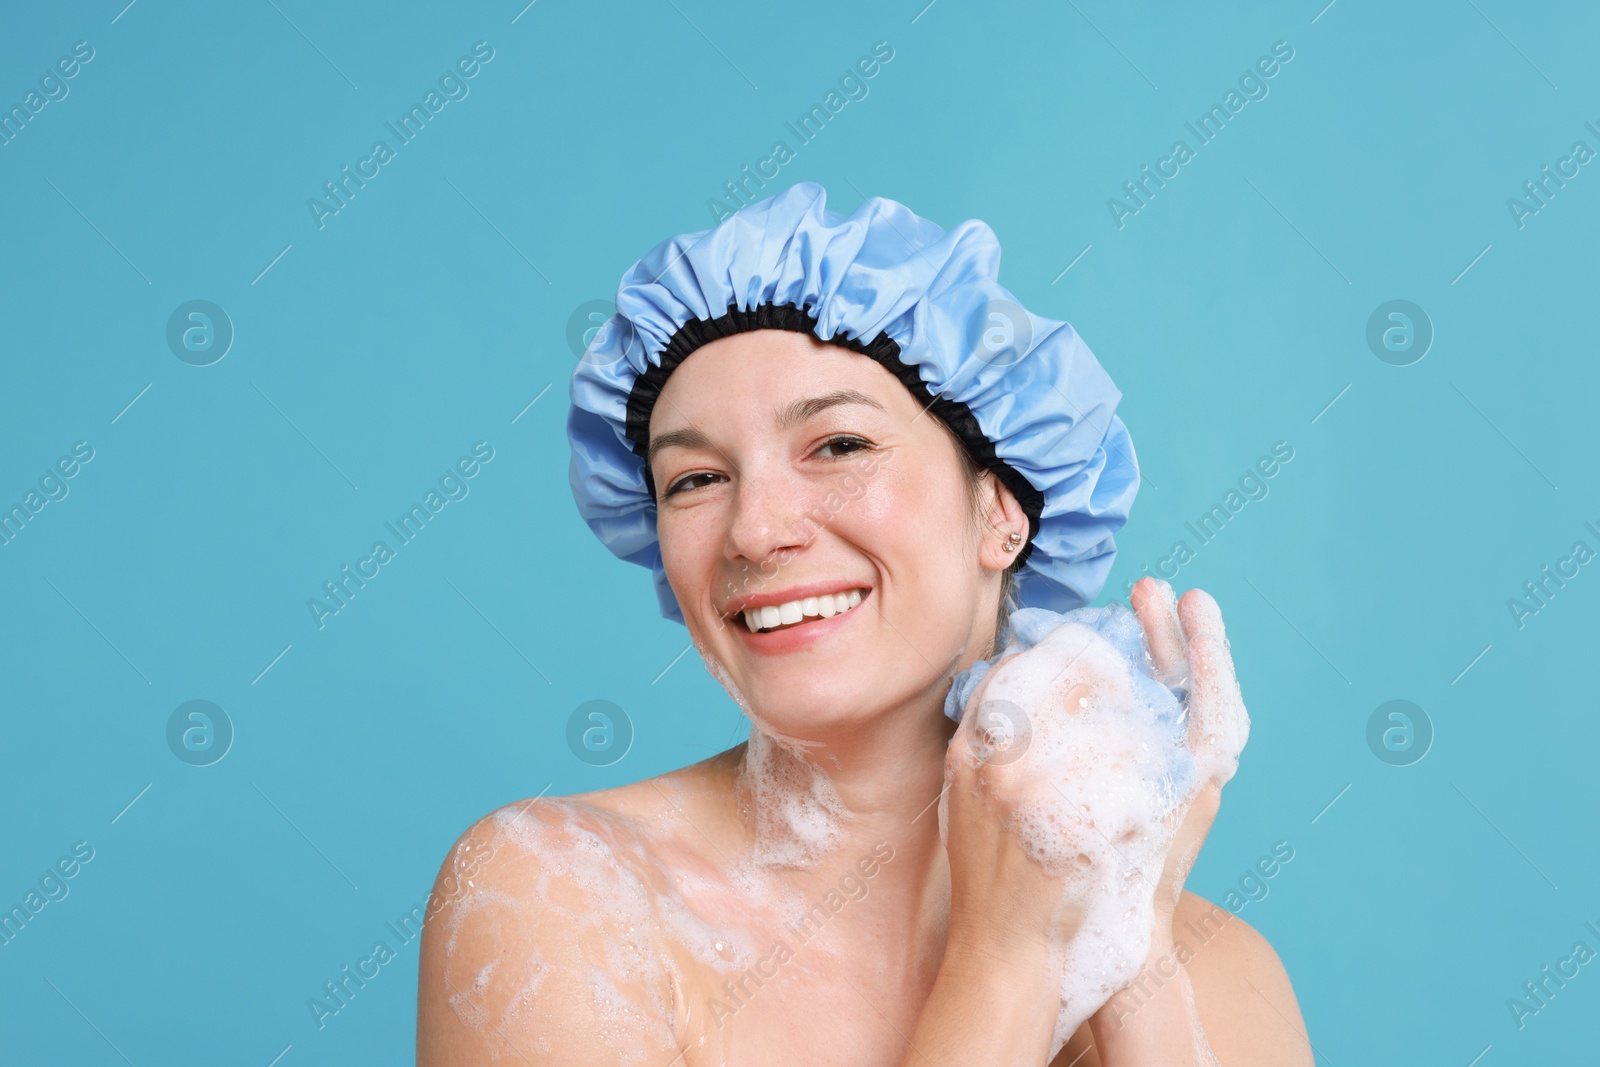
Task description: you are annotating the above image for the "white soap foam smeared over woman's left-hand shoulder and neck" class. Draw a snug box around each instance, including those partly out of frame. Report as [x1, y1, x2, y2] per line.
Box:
[440, 783, 842, 1067]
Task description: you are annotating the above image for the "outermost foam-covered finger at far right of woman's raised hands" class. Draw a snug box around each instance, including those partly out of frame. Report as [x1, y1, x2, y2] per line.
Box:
[1178, 589, 1250, 782]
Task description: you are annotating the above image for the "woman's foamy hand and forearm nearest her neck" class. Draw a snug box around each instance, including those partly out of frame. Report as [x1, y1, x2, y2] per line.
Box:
[904, 619, 1160, 1067]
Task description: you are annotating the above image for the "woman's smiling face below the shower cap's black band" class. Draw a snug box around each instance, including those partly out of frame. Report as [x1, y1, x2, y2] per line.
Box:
[650, 330, 998, 739]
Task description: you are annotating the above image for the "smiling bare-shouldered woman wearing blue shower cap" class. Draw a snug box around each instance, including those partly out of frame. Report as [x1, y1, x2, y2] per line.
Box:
[418, 182, 1312, 1067]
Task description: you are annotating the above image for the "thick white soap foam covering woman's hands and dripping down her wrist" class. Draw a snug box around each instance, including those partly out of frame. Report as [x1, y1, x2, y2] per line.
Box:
[939, 603, 1250, 1057]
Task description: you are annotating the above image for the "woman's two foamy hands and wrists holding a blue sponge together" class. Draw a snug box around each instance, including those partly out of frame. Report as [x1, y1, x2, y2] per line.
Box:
[918, 582, 1248, 1064]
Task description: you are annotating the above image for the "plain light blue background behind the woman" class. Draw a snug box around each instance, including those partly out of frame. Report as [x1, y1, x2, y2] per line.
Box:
[0, 0, 1600, 1067]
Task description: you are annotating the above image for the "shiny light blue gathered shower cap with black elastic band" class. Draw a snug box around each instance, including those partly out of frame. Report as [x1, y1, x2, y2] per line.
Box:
[566, 182, 1139, 622]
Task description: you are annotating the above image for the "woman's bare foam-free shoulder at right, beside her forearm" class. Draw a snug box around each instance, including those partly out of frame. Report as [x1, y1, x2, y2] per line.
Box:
[1173, 891, 1314, 1067]
